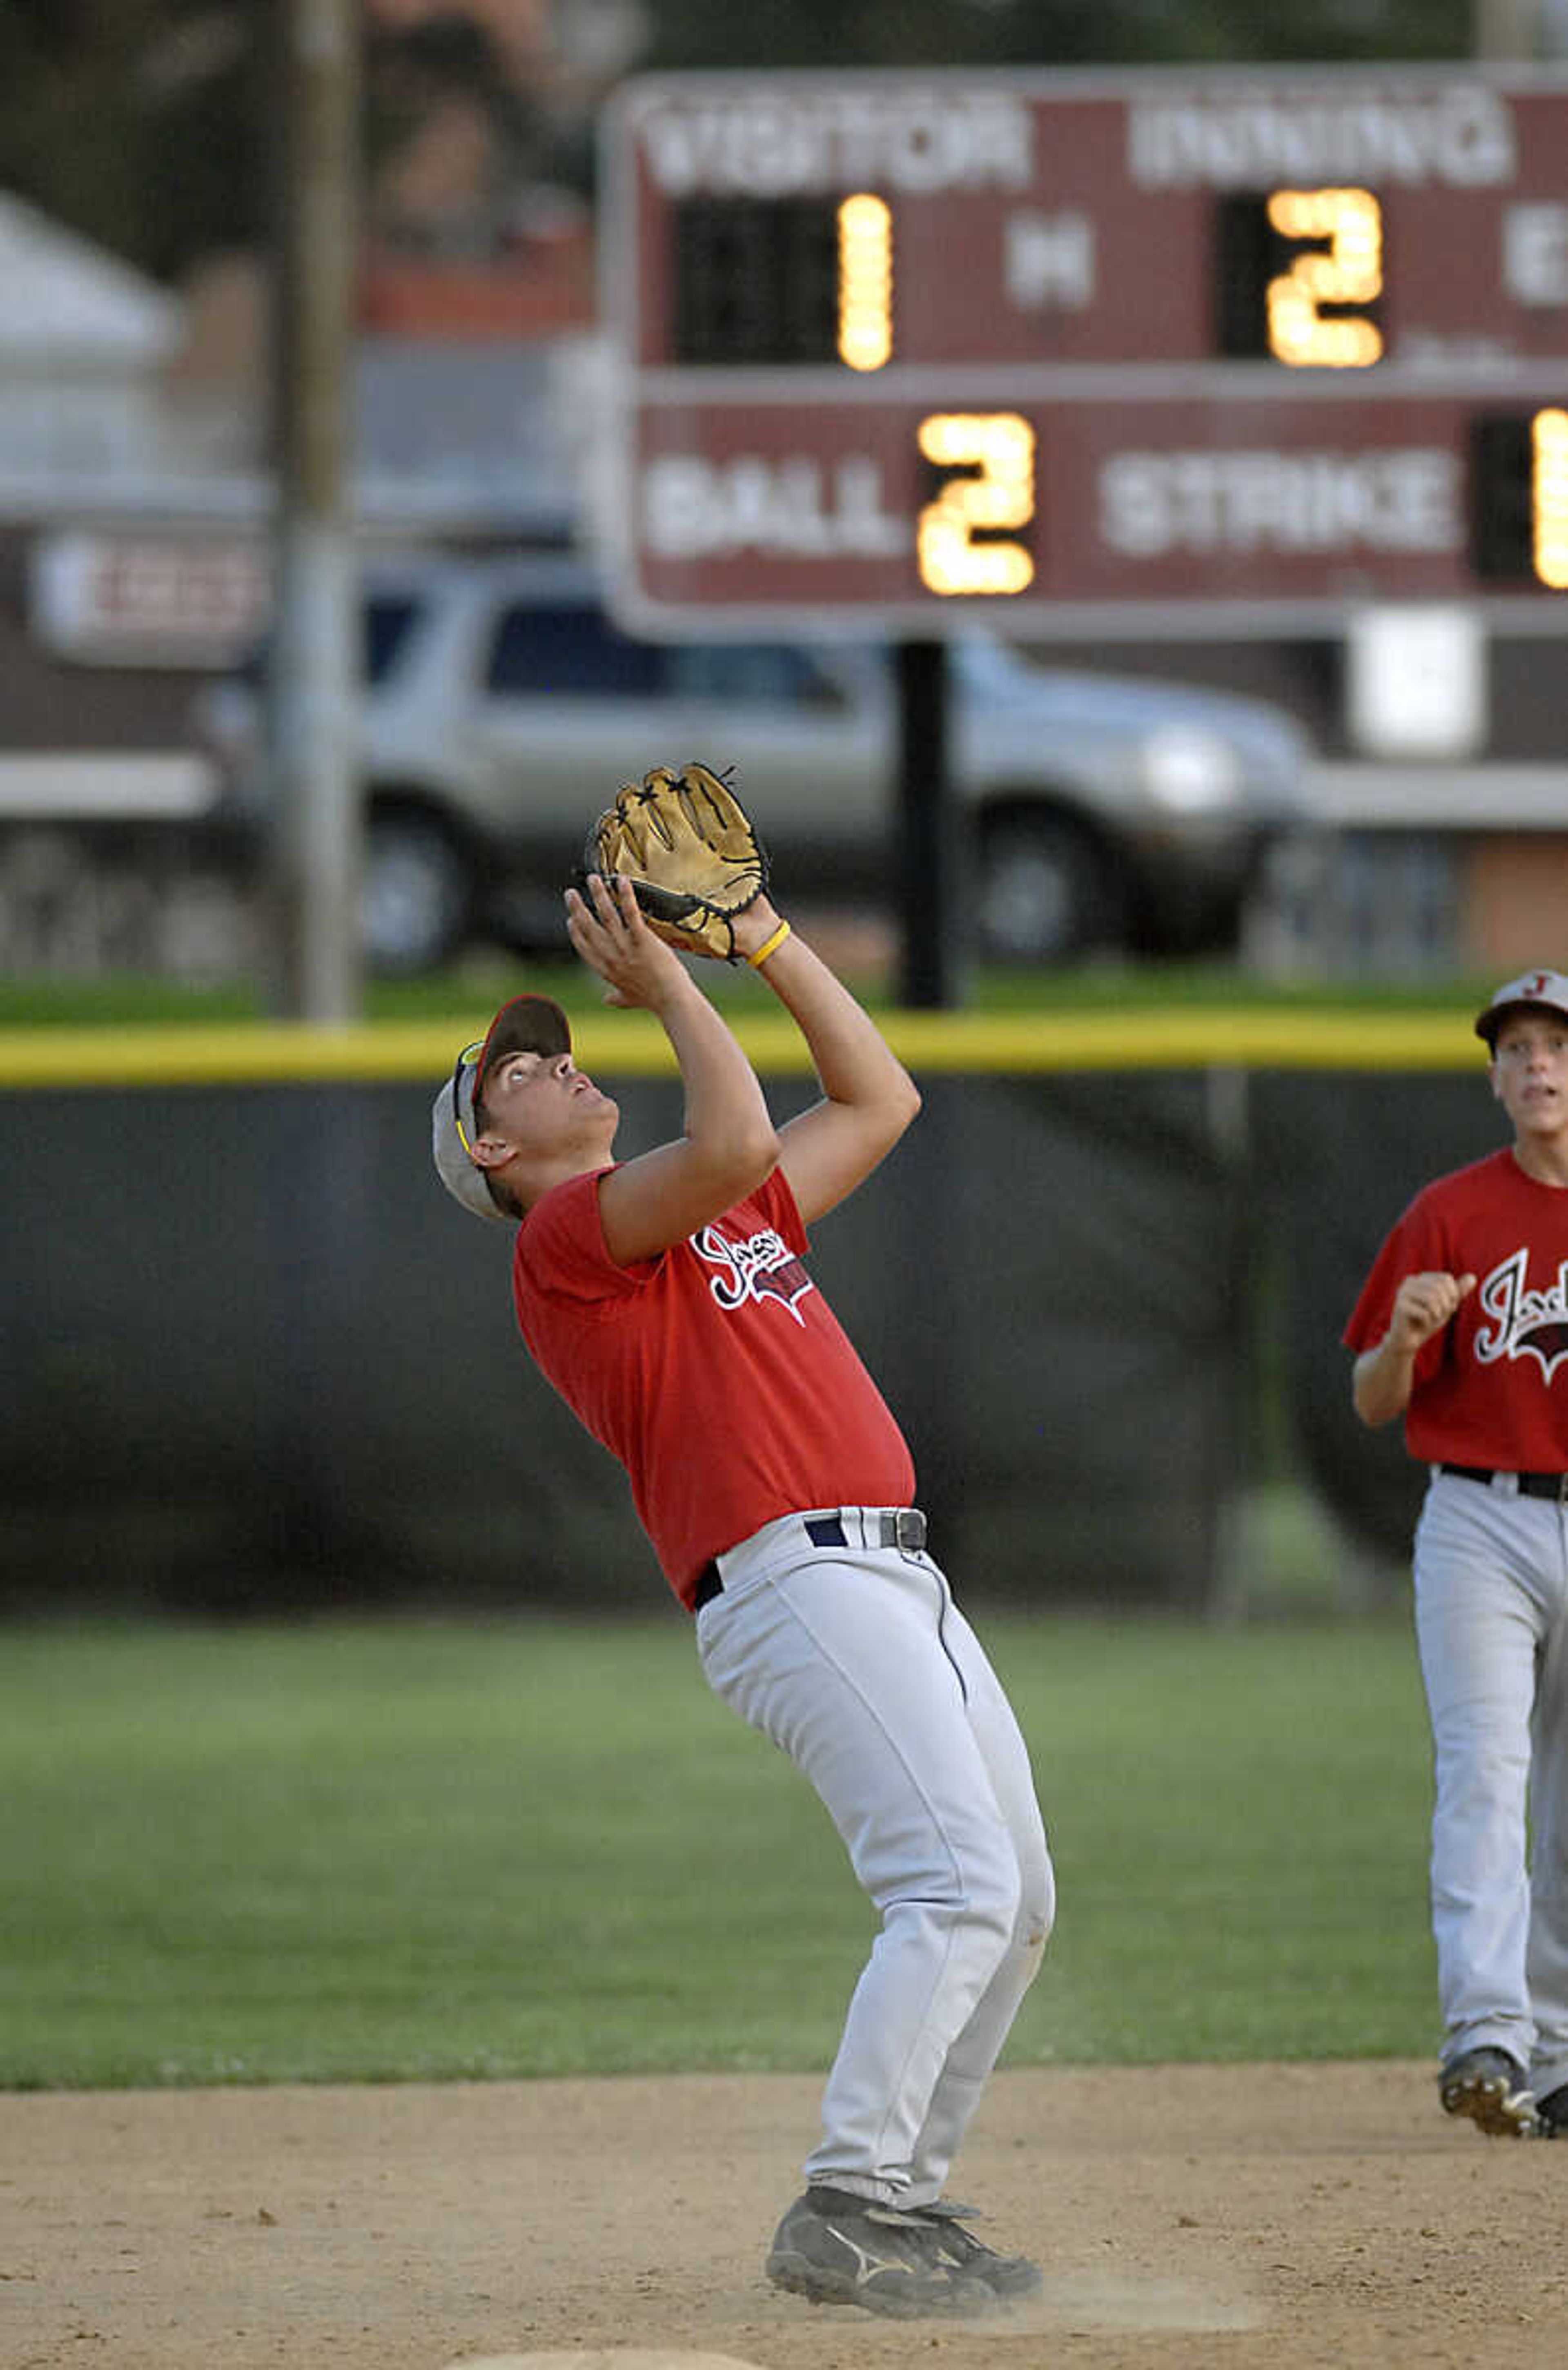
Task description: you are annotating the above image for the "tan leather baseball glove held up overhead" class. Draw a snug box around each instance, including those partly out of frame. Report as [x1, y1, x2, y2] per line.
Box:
[583, 766, 767, 962]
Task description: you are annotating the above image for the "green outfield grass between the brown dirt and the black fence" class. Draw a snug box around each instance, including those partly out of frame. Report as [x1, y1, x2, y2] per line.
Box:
[0, 1609, 1435, 2088]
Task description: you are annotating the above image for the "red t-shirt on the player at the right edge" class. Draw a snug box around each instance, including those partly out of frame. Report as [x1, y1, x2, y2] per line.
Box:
[1345, 1149, 1568, 1472]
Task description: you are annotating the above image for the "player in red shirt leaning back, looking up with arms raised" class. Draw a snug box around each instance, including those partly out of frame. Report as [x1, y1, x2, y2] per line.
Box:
[434, 875, 1054, 2316]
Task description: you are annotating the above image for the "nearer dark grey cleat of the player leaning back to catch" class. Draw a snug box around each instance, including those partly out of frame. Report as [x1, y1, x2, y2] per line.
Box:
[767, 2185, 997, 2320]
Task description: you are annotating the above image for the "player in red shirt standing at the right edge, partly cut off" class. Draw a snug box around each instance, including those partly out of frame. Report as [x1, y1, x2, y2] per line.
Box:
[1345, 972, 1568, 2138]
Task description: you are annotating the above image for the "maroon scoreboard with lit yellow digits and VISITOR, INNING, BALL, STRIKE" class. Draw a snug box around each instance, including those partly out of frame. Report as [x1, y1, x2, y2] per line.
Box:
[601, 64, 1568, 640]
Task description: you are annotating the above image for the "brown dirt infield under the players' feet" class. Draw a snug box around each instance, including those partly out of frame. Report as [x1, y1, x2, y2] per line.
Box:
[0, 2064, 1568, 2370]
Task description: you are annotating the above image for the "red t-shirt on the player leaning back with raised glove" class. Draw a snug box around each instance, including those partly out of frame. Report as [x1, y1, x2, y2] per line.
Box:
[512, 1168, 914, 1604]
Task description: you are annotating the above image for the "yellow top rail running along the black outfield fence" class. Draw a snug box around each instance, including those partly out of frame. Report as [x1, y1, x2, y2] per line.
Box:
[0, 1005, 1485, 1093]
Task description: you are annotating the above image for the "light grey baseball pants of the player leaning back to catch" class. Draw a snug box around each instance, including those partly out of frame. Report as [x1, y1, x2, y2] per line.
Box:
[696, 1507, 1056, 2207]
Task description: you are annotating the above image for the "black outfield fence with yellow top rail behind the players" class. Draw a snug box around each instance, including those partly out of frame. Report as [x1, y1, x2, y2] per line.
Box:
[0, 1017, 1499, 1614]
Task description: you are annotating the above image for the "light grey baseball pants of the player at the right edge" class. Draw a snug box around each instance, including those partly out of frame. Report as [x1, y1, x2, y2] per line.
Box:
[1414, 1474, 1568, 2098]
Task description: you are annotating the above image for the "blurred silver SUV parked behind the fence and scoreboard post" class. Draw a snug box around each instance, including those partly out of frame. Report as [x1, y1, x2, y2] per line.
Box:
[199, 555, 1312, 972]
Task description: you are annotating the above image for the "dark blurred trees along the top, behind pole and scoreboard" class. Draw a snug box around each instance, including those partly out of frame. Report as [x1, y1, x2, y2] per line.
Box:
[0, 0, 1473, 280]
